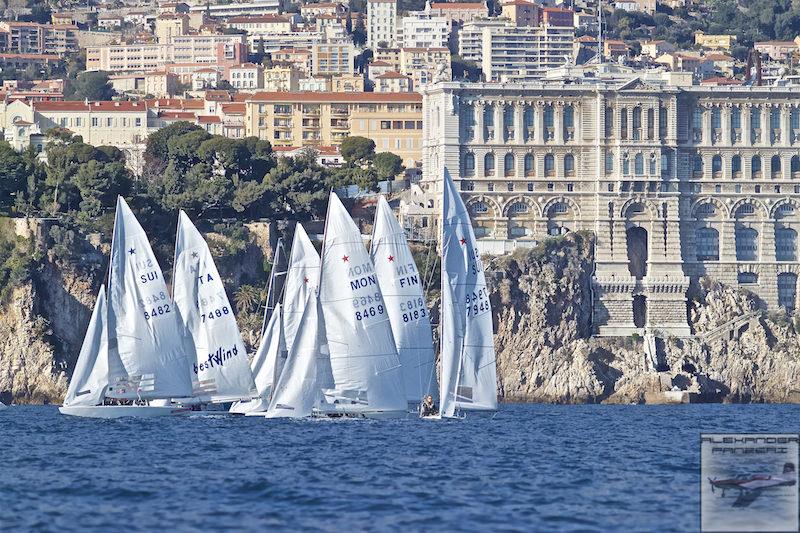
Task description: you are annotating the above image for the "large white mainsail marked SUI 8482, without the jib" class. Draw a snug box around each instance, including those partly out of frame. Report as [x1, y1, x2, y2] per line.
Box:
[108, 197, 192, 398]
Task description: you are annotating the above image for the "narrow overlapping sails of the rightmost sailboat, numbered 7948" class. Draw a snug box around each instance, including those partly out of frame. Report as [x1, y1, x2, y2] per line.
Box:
[440, 169, 497, 417]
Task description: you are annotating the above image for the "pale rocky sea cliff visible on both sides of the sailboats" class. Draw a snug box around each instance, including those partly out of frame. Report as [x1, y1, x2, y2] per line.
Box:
[0, 219, 800, 403]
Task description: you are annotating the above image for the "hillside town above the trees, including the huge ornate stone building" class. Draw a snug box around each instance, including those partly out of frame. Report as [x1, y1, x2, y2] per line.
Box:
[0, 0, 800, 335]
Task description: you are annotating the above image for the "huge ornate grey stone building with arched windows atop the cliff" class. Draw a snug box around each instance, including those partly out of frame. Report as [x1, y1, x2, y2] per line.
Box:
[423, 72, 800, 335]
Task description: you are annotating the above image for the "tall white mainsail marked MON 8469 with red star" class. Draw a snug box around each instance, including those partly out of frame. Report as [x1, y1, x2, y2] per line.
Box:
[320, 192, 407, 411]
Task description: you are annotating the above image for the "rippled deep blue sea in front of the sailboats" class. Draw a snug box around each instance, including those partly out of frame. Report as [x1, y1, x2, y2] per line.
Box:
[0, 405, 800, 532]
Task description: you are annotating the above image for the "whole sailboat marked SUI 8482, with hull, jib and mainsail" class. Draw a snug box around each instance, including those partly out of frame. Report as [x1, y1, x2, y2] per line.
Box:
[59, 197, 192, 418]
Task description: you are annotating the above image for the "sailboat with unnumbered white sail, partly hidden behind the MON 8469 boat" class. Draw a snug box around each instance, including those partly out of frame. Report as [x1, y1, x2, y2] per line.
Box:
[230, 223, 319, 416]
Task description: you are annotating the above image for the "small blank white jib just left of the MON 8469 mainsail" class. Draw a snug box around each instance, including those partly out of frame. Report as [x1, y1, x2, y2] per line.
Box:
[266, 292, 327, 418]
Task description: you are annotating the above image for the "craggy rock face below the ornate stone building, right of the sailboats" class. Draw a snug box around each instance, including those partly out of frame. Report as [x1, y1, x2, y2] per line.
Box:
[487, 233, 800, 403]
